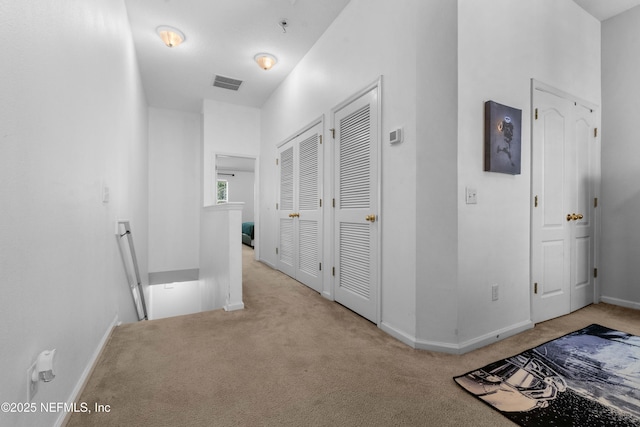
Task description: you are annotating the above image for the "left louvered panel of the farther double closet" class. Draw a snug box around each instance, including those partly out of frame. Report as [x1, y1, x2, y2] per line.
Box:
[277, 144, 296, 276]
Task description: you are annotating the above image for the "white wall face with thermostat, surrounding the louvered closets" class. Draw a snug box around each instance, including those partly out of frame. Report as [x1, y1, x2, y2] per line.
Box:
[259, 0, 418, 342]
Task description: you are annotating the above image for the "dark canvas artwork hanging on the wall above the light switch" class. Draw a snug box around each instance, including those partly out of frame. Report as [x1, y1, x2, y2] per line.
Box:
[484, 101, 522, 175]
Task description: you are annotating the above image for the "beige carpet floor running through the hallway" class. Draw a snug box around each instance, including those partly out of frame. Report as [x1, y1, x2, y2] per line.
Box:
[67, 248, 640, 427]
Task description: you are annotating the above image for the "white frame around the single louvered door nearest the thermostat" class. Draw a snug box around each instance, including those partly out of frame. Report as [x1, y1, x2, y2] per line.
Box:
[330, 75, 384, 327]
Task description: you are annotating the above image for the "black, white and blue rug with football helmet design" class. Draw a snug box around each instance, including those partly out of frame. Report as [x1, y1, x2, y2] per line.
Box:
[454, 325, 640, 427]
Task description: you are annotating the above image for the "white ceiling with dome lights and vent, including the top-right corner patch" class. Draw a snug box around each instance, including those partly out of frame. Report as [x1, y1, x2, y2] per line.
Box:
[125, 0, 640, 112]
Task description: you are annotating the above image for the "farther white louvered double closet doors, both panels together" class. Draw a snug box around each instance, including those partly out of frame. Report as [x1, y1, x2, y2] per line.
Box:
[277, 123, 322, 292]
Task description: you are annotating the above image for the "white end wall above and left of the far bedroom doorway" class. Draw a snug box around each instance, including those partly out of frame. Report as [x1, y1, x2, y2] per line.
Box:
[202, 99, 260, 206]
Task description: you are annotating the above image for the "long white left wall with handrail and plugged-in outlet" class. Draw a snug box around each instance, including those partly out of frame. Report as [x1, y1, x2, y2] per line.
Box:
[0, 0, 148, 426]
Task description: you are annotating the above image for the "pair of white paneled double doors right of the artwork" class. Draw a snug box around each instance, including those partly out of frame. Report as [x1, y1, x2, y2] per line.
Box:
[531, 84, 599, 322]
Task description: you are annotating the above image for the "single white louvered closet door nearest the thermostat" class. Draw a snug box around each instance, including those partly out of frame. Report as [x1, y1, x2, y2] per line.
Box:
[334, 88, 379, 323]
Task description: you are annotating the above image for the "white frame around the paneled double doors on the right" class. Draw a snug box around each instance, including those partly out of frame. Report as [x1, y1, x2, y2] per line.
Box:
[529, 78, 602, 319]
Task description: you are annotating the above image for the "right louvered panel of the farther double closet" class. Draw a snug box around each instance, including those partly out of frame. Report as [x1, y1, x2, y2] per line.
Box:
[296, 124, 322, 292]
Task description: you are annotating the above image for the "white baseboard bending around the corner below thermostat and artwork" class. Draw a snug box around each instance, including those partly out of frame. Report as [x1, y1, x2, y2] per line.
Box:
[380, 320, 534, 354]
